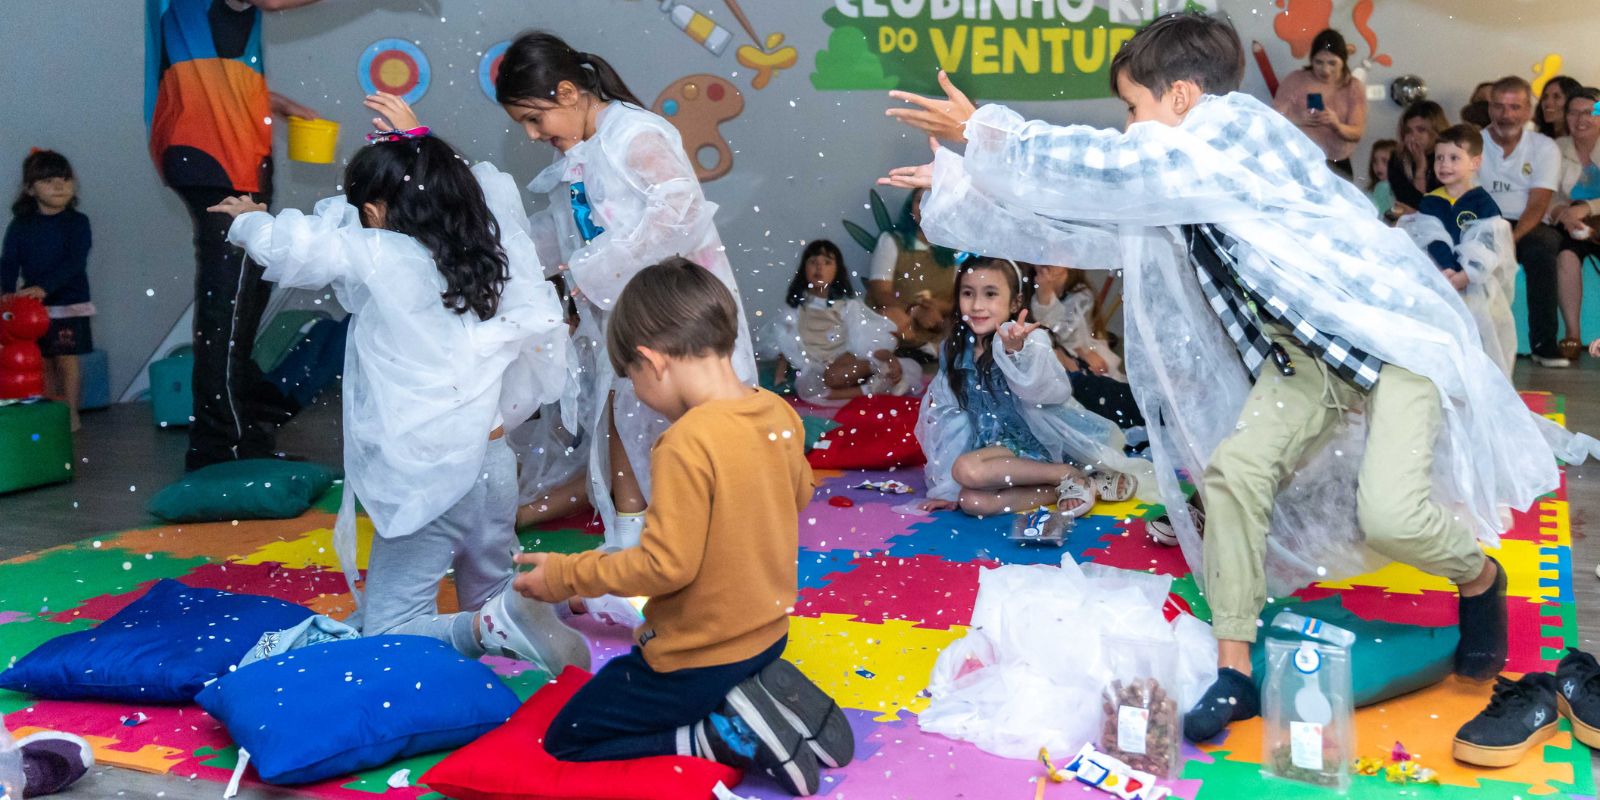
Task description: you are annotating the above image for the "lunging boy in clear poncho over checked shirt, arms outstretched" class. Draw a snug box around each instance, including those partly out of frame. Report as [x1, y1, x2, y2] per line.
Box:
[883, 13, 1594, 739]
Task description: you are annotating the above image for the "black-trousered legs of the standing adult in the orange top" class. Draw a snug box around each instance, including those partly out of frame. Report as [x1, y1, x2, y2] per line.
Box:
[178, 187, 274, 469]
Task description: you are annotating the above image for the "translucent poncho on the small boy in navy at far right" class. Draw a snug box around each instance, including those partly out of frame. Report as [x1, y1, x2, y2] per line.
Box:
[1395, 214, 1517, 378]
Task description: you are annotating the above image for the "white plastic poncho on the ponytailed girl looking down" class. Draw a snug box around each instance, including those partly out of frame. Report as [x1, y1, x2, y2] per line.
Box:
[528, 102, 755, 544]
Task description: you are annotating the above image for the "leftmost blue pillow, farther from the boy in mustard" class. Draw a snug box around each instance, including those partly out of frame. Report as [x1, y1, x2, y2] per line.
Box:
[0, 579, 310, 702]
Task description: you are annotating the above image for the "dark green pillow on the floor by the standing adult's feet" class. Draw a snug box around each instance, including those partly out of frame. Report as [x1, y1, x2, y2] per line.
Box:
[146, 458, 339, 522]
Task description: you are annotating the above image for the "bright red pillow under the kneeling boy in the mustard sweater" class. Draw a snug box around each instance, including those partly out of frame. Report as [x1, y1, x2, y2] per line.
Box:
[422, 667, 744, 800]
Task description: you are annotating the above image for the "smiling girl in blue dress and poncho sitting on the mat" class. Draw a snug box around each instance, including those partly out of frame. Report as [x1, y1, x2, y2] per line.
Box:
[917, 258, 1154, 517]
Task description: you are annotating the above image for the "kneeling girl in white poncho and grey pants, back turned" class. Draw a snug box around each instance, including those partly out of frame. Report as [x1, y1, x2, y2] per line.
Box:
[213, 124, 589, 674]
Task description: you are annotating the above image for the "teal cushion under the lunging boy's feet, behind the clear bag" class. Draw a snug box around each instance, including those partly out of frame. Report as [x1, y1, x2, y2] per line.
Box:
[1250, 595, 1461, 706]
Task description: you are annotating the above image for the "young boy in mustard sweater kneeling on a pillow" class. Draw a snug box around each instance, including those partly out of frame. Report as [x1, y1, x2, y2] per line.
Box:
[514, 258, 856, 795]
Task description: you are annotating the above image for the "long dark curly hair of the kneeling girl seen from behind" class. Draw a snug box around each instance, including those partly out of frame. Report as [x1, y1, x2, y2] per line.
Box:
[344, 136, 510, 320]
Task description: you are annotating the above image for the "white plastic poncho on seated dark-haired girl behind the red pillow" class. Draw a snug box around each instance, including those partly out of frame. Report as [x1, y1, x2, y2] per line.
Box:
[757, 296, 922, 406]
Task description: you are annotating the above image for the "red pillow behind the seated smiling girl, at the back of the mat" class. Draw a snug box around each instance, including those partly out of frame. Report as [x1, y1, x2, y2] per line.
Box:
[806, 395, 928, 469]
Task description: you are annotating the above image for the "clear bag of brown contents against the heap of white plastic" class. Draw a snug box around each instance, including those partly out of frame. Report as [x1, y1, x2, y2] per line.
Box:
[1096, 635, 1182, 778]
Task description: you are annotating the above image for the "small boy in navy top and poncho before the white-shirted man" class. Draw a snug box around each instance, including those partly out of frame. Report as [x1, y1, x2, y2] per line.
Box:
[1397, 123, 1517, 378]
